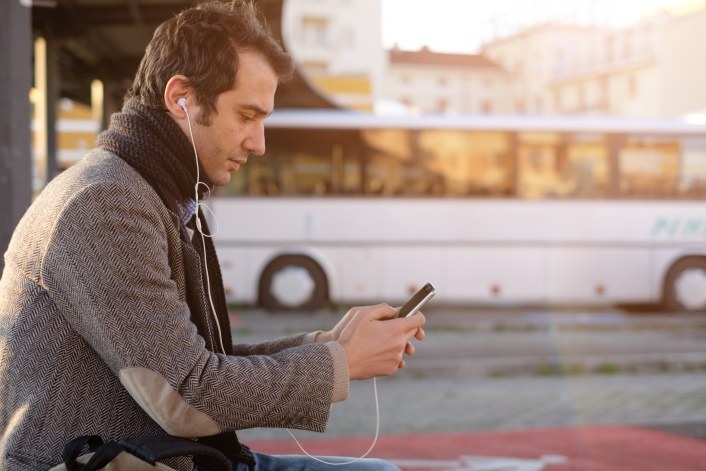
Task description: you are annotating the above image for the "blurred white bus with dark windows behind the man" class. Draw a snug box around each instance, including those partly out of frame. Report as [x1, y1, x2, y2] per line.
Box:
[210, 110, 706, 311]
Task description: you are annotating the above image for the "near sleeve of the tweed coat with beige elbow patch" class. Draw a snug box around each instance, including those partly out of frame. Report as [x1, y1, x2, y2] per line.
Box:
[42, 182, 348, 437]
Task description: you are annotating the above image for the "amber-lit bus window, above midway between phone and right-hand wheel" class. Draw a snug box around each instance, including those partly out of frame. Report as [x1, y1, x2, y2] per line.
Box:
[518, 132, 610, 199]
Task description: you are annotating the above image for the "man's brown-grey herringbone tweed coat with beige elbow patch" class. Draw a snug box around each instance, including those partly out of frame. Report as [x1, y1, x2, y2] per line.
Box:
[0, 150, 348, 471]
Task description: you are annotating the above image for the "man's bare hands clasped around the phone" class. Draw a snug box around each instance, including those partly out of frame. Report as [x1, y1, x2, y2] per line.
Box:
[324, 304, 426, 379]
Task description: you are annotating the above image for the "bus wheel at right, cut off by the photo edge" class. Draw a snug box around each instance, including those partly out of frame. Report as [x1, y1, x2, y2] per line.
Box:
[663, 257, 706, 312]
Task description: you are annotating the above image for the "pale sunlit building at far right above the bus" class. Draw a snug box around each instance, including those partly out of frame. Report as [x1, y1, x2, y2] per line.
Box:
[549, 2, 706, 117]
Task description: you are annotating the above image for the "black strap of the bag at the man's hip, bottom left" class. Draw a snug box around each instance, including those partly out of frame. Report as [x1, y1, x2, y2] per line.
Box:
[62, 435, 231, 471]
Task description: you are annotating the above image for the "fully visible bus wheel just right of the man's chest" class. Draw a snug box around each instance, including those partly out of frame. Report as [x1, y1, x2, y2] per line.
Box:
[259, 255, 328, 311]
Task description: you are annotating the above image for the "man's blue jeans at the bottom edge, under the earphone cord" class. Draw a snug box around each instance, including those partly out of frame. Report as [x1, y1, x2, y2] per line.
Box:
[209, 451, 400, 471]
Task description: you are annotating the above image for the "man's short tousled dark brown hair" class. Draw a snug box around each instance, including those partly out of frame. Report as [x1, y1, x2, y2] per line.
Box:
[127, 0, 294, 121]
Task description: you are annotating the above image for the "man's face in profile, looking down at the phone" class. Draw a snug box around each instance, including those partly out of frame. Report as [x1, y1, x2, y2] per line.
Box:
[189, 51, 277, 186]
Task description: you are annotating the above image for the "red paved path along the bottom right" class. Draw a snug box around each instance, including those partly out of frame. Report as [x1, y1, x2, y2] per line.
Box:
[248, 426, 706, 471]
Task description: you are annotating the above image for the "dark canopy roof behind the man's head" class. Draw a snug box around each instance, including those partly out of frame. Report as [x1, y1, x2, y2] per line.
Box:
[33, 0, 335, 108]
